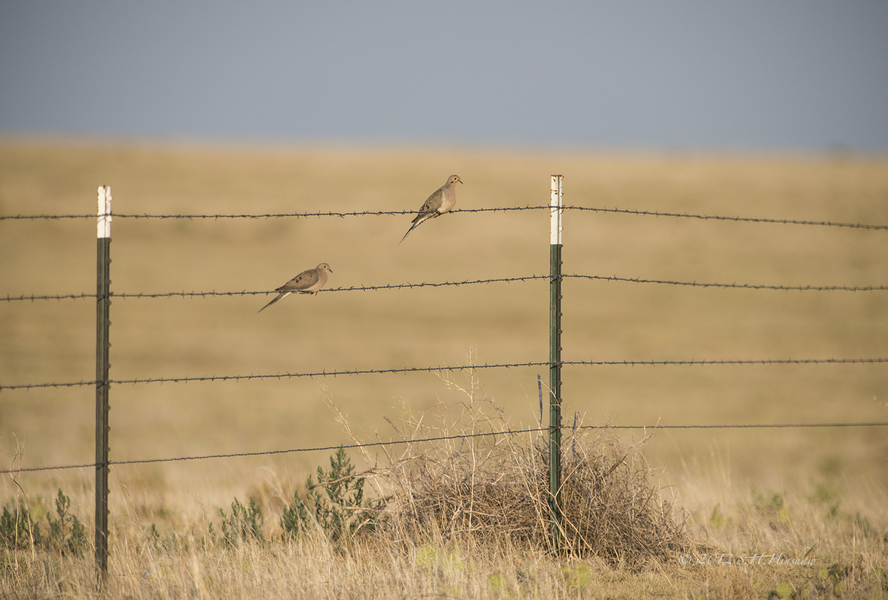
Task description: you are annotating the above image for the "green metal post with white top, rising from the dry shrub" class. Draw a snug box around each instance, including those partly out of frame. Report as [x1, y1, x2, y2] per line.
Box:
[549, 175, 563, 550]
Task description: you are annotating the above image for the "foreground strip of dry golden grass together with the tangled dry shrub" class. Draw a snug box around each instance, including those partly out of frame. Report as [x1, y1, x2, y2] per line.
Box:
[0, 376, 888, 599]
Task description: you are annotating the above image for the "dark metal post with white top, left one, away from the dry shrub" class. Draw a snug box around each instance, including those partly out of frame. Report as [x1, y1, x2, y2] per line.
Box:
[95, 186, 111, 579]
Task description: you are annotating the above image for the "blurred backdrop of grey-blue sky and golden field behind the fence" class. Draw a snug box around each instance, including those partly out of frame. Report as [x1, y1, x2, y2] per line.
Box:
[0, 1, 888, 504]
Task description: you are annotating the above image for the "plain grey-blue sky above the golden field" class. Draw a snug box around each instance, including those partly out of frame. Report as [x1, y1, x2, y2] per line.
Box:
[0, 0, 888, 151]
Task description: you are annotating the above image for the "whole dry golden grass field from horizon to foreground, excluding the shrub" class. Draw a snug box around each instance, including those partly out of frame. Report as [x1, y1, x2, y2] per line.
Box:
[0, 139, 888, 598]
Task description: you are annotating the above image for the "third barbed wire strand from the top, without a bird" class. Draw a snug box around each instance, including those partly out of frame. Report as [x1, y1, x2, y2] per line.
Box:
[0, 357, 888, 391]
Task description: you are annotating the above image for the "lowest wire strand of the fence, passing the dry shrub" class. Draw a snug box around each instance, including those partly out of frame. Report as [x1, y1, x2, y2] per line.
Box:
[0, 422, 888, 475]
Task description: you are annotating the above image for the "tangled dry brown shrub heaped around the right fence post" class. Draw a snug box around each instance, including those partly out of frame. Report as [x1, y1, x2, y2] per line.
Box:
[346, 371, 687, 567]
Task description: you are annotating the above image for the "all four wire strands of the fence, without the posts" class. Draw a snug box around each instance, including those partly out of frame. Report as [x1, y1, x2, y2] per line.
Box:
[0, 197, 888, 474]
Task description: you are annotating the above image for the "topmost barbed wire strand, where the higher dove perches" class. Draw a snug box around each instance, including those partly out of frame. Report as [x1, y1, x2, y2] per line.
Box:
[0, 205, 888, 230]
